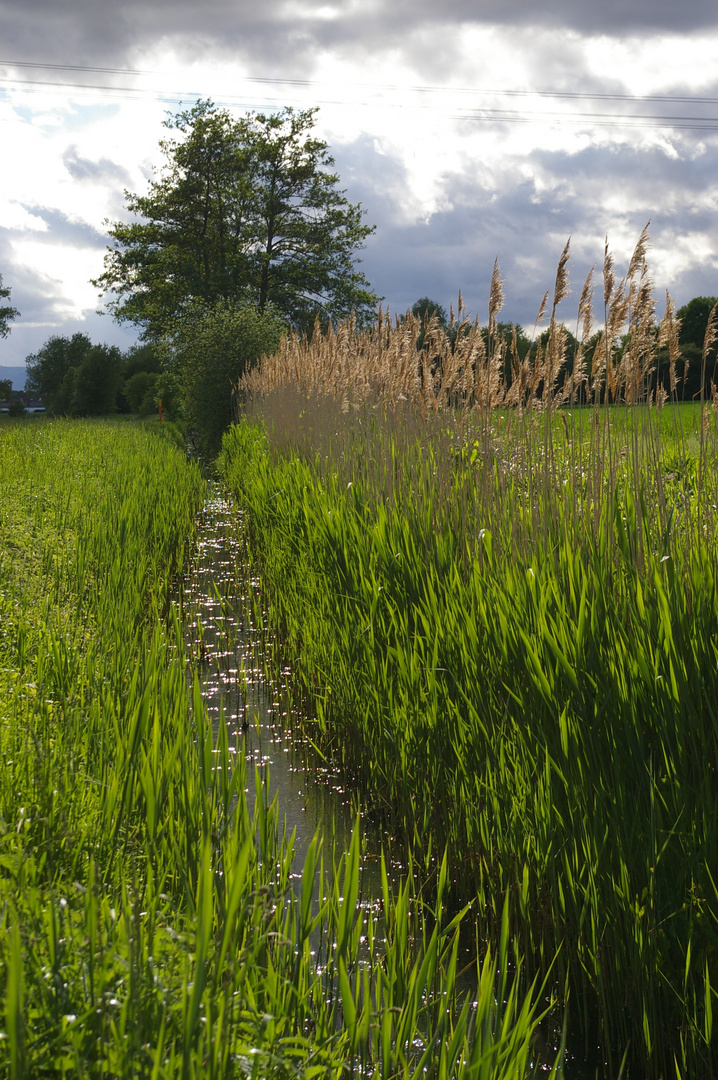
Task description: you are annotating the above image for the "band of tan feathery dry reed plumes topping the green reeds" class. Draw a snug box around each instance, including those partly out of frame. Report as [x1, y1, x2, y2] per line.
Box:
[238, 225, 686, 418]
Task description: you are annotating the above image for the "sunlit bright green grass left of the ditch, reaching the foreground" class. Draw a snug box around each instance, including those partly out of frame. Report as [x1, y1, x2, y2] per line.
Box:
[0, 421, 546, 1080]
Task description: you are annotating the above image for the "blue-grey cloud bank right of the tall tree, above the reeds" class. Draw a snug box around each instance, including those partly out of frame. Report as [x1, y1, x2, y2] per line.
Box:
[336, 131, 718, 328]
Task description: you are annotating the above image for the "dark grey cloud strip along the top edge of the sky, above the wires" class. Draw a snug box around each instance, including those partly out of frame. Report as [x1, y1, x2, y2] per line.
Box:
[0, 0, 718, 73]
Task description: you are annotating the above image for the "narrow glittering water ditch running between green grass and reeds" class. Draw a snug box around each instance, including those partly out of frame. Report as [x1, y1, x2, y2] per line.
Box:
[174, 481, 593, 1080]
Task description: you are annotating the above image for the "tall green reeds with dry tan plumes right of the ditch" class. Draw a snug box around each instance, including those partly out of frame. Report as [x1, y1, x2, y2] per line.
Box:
[219, 234, 718, 1078]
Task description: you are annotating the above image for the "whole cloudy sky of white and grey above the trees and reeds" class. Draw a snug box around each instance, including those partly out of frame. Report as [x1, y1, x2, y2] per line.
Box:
[0, 0, 718, 365]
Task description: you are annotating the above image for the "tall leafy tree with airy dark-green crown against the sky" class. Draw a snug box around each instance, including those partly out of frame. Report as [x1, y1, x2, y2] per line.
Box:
[94, 102, 380, 338]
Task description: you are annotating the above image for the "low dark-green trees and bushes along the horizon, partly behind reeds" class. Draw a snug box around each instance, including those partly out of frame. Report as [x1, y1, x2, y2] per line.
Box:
[16, 296, 718, 434]
